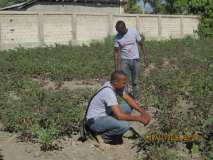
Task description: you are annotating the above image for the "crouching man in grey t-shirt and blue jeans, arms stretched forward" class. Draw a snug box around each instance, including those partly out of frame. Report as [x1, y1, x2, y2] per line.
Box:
[86, 71, 150, 144]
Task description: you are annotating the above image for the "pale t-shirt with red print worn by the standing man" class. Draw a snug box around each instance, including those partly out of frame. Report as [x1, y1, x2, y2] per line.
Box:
[114, 28, 142, 59]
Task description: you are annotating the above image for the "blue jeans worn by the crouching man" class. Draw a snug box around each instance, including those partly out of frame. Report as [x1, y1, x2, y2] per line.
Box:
[90, 102, 132, 139]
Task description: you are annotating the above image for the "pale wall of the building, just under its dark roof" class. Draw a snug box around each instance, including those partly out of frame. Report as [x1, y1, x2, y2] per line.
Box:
[26, 4, 124, 14]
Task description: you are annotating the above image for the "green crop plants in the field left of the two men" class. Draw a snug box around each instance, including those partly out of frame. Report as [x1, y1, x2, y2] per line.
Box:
[0, 40, 106, 150]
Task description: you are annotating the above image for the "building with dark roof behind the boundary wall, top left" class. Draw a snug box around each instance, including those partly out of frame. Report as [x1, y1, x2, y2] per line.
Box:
[1, 0, 125, 14]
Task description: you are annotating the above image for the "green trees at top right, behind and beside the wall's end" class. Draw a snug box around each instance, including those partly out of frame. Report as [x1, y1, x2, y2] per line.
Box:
[148, 0, 213, 38]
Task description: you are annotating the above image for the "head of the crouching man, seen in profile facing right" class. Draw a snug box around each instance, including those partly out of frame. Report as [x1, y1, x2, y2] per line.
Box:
[110, 71, 128, 89]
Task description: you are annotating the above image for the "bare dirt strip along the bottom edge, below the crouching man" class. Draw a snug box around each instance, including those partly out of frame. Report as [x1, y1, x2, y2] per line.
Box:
[0, 124, 146, 160]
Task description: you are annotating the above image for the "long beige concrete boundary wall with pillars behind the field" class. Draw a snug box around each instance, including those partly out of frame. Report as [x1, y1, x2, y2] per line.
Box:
[0, 11, 199, 50]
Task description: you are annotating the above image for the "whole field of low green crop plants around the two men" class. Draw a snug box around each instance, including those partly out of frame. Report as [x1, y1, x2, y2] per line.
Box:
[0, 38, 213, 160]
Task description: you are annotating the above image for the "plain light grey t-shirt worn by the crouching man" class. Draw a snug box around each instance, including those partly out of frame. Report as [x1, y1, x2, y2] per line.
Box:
[86, 82, 124, 119]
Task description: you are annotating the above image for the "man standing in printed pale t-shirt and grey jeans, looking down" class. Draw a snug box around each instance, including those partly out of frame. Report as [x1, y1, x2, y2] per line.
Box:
[114, 21, 148, 101]
